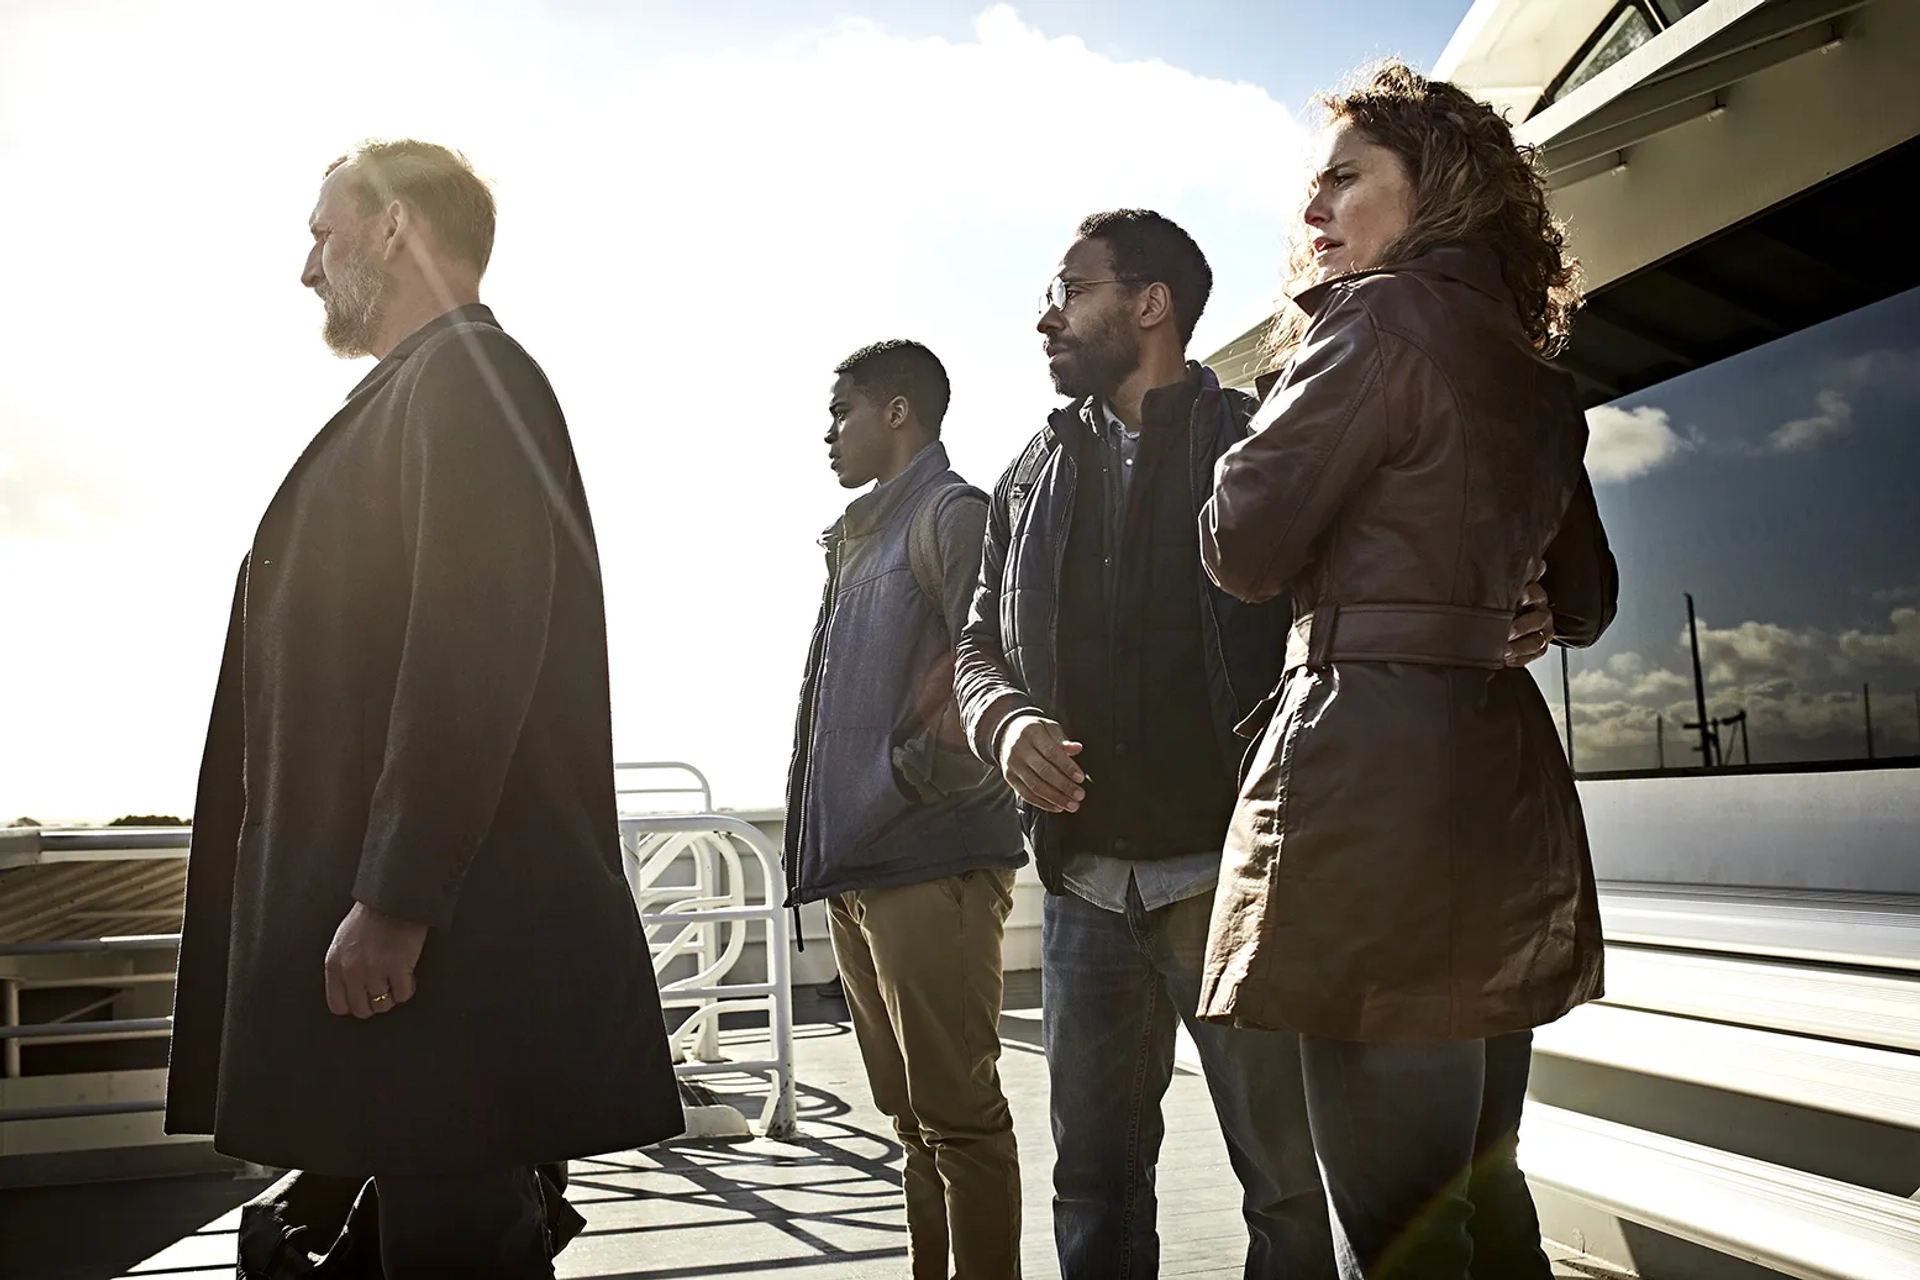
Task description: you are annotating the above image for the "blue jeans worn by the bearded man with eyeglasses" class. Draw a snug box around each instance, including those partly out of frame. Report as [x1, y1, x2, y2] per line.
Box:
[1041, 890, 1334, 1280]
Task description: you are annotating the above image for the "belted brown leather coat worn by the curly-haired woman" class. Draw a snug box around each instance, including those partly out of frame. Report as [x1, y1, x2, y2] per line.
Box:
[1200, 246, 1619, 1042]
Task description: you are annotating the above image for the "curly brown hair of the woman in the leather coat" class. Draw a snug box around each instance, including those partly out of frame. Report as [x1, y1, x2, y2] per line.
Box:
[1269, 58, 1580, 361]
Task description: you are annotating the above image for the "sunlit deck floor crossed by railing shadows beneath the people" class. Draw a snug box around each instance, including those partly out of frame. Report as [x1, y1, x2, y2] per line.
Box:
[0, 973, 1246, 1280]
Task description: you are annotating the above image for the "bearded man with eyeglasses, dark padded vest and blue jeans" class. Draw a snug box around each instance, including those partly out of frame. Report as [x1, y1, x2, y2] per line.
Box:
[956, 209, 1334, 1280]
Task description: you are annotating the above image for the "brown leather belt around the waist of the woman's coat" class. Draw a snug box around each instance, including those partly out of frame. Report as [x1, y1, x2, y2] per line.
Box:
[1286, 604, 1513, 672]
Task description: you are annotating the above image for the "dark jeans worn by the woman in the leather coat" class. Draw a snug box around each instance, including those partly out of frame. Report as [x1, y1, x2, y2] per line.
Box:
[1300, 1031, 1551, 1280]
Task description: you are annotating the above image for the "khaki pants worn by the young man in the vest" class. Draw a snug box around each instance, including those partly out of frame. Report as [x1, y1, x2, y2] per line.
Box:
[828, 871, 1020, 1280]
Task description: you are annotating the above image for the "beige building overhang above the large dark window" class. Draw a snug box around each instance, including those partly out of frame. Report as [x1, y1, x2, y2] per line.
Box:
[1210, 0, 1920, 405]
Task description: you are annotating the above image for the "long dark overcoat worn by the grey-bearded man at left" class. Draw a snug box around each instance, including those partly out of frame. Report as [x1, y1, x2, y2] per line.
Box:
[167, 305, 682, 1174]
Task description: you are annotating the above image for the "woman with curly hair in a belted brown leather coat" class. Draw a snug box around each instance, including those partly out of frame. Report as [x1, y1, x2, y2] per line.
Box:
[1200, 63, 1619, 1280]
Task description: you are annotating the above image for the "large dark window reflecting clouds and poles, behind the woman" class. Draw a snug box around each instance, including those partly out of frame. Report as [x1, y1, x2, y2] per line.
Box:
[1534, 290, 1920, 773]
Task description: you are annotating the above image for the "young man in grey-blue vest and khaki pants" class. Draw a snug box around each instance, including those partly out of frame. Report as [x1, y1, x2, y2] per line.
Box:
[785, 342, 1025, 1280]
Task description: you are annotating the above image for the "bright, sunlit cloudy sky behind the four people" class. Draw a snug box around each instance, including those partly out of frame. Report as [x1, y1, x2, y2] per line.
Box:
[0, 0, 1466, 821]
